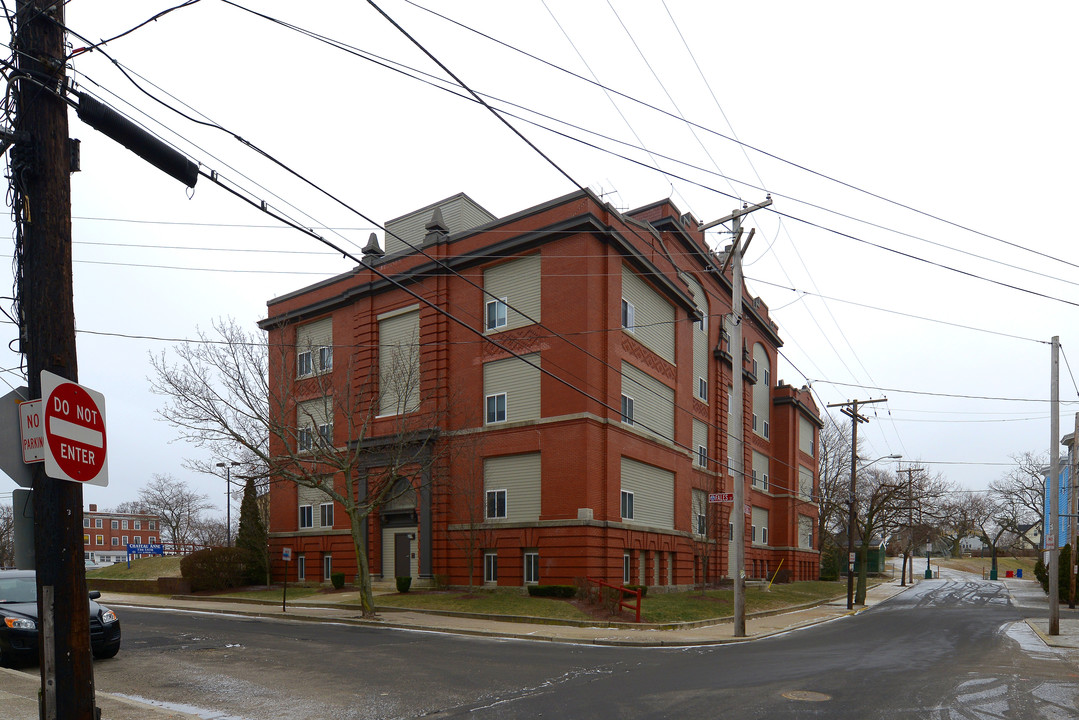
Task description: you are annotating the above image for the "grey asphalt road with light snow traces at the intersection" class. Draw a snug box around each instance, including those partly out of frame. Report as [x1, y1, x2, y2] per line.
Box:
[94, 580, 1079, 720]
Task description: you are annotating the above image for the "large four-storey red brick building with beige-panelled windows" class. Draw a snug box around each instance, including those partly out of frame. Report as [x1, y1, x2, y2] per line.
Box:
[261, 191, 821, 586]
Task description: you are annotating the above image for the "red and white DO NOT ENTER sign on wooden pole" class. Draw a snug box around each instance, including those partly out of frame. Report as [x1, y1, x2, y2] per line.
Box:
[41, 370, 109, 487]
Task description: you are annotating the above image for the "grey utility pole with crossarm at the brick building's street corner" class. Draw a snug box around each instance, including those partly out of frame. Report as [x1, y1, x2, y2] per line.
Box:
[698, 195, 771, 638]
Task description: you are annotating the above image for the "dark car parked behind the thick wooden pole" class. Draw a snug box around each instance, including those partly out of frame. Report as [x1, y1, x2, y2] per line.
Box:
[0, 570, 120, 665]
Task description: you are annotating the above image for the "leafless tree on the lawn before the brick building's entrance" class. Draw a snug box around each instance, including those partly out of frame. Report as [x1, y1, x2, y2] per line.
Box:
[151, 320, 445, 615]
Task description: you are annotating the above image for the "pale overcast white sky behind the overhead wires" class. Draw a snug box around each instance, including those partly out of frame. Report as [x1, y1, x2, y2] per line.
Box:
[0, 0, 1079, 515]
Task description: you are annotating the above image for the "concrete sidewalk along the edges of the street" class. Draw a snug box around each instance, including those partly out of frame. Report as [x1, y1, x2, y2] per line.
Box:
[0, 579, 1079, 720]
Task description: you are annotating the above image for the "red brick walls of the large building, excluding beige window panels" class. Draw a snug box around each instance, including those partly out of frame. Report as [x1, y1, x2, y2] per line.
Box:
[262, 192, 820, 586]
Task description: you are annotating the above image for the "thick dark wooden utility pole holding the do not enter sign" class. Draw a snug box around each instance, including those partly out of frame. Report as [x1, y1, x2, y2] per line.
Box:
[11, 0, 95, 720]
